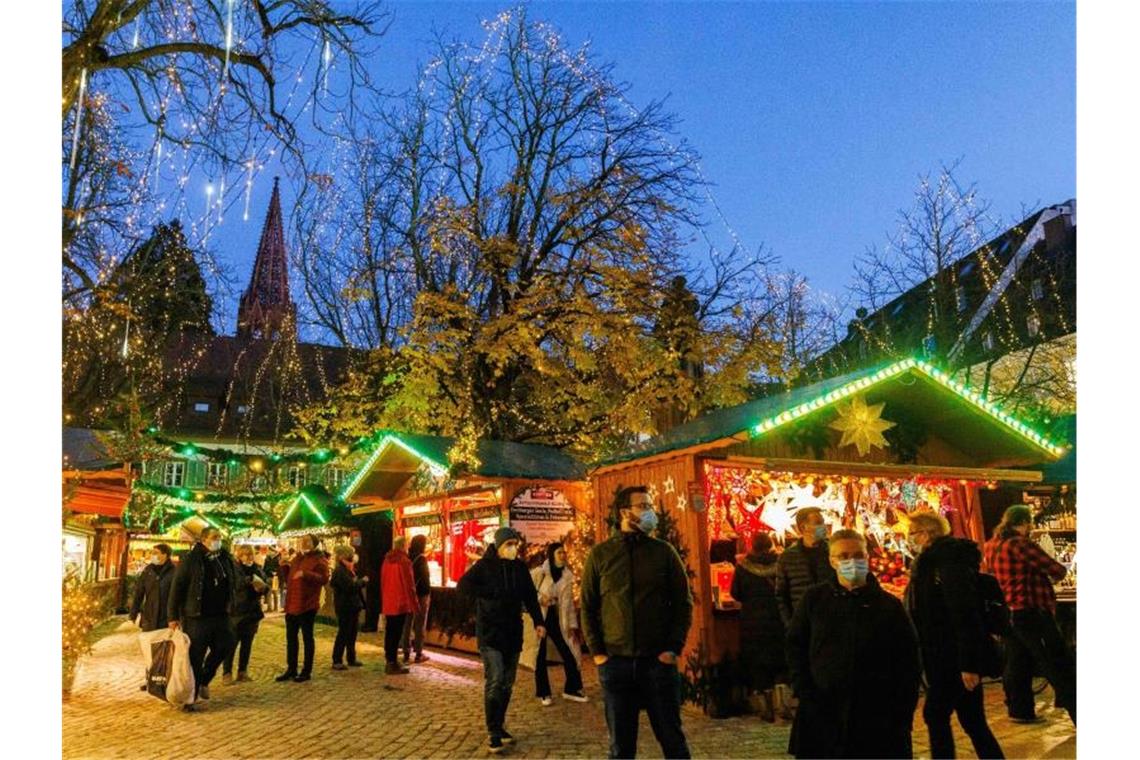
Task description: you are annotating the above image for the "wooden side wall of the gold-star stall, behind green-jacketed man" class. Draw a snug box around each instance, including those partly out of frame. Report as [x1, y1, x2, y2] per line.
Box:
[592, 456, 713, 663]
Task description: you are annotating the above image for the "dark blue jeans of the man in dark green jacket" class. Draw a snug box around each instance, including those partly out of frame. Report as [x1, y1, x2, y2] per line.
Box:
[597, 657, 692, 758]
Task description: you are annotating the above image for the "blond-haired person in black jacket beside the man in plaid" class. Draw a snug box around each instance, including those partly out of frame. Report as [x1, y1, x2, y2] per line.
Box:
[906, 512, 1005, 758]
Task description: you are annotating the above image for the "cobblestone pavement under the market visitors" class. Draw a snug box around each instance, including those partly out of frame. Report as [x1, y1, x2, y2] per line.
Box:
[63, 614, 1076, 760]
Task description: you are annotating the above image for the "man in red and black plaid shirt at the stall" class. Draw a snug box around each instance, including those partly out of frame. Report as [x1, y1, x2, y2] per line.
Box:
[985, 504, 1076, 725]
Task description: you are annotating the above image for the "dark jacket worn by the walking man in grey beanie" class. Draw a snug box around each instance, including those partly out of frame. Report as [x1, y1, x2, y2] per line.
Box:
[458, 544, 543, 653]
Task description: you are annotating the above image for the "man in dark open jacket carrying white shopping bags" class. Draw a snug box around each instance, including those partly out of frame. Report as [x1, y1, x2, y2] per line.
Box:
[168, 525, 241, 706]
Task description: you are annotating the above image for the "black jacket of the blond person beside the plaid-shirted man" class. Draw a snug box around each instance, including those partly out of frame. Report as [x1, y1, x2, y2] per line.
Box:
[906, 536, 996, 683]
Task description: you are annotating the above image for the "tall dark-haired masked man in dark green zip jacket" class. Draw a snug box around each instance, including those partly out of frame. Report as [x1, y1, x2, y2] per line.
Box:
[581, 487, 693, 758]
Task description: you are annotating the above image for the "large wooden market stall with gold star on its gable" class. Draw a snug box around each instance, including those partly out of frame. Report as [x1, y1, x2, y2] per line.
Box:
[591, 359, 1064, 715]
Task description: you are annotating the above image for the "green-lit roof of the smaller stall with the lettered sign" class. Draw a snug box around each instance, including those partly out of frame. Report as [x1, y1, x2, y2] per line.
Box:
[340, 431, 586, 499]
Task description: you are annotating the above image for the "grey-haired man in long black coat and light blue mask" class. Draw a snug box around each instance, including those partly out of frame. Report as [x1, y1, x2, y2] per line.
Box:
[788, 530, 921, 758]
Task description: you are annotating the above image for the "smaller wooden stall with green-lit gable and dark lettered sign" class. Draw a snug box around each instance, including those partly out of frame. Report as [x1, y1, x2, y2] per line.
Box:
[340, 433, 593, 651]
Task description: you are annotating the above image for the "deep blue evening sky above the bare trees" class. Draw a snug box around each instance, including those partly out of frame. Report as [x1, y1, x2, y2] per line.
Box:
[211, 2, 1076, 330]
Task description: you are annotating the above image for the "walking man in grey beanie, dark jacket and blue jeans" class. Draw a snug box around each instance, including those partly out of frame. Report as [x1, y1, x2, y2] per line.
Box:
[459, 526, 546, 754]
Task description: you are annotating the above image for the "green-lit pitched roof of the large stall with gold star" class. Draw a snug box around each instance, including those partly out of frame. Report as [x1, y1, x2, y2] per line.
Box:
[597, 359, 1065, 469]
